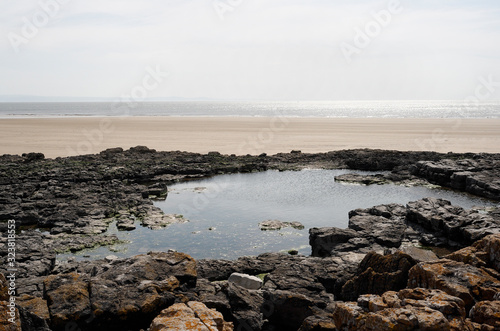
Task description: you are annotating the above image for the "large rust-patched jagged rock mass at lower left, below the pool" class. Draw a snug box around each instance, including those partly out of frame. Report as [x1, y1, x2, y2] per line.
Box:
[40, 252, 197, 330]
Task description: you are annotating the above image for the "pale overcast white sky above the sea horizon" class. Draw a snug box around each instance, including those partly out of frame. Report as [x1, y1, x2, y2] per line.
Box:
[0, 0, 500, 101]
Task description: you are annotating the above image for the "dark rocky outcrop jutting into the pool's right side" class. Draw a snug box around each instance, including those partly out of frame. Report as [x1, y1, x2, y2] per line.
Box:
[309, 198, 500, 259]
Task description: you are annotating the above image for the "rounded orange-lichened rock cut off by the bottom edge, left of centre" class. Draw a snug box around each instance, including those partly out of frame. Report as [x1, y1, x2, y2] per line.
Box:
[150, 301, 233, 331]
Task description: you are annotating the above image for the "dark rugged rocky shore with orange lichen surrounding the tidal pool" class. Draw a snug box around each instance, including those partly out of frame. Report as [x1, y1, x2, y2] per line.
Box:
[0, 146, 500, 331]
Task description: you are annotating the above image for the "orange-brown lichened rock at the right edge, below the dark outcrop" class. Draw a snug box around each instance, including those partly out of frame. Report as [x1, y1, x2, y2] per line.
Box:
[408, 259, 500, 309]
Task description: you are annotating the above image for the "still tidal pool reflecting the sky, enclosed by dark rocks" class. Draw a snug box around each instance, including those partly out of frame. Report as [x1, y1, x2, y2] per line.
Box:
[59, 170, 496, 259]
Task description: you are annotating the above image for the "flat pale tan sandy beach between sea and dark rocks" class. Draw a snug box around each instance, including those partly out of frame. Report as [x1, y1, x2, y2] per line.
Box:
[0, 117, 500, 158]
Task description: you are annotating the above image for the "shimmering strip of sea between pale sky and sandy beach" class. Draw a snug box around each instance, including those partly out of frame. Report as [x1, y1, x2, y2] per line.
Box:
[0, 100, 500, 118]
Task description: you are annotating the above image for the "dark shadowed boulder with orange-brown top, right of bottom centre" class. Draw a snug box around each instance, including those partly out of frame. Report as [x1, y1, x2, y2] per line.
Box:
[341, 252, 416, 301]
